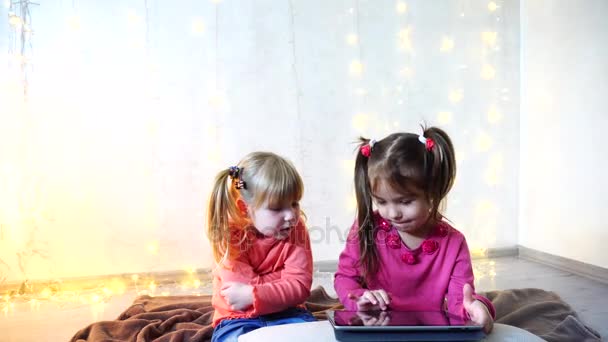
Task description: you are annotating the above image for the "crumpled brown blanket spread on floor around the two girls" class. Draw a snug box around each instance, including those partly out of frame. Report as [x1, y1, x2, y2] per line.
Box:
[71, 287, 600, 342]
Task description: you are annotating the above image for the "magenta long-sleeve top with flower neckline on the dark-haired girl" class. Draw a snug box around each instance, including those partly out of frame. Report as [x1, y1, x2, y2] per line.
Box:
[334, 213, 495, 317]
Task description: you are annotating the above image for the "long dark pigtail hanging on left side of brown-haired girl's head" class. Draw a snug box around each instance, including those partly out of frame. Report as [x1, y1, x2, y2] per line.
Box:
[355, 137, 378, 280]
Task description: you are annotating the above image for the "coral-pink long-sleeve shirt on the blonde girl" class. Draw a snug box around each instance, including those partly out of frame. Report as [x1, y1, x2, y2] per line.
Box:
[211, 220, 312, 326]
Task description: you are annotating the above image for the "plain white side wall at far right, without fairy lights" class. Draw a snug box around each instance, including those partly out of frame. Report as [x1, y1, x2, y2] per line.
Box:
[519, 0, 608, 267]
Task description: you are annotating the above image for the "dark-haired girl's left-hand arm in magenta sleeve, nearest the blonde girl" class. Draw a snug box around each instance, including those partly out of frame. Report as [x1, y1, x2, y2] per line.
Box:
[334, 223, 367, 310]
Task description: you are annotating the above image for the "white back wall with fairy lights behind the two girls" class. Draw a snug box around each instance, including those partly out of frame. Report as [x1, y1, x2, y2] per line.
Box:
[0, 0, 520, 282]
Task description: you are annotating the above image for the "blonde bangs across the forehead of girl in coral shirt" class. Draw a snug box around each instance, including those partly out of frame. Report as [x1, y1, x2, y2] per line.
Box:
[253, 161, 304, 208]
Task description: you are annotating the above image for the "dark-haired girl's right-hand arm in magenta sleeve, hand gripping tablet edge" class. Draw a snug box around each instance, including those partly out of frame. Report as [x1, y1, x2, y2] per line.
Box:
[447, 237, 496, 319]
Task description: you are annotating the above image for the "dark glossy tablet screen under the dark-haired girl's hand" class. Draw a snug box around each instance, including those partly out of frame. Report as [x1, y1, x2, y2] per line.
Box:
[329, 310, 482, 330]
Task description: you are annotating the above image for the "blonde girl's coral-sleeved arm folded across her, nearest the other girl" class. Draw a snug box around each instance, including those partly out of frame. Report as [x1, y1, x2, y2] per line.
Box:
[253, 223, 312, 315]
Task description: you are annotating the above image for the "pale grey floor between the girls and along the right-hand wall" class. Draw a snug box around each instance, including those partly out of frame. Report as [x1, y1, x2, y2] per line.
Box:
[313, 257, 608, 340]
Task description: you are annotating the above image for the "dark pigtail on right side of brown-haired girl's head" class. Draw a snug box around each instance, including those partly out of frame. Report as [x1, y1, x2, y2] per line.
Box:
[423, 127, 456, 219]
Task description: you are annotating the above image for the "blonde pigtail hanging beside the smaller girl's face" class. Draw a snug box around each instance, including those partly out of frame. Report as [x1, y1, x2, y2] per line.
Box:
[207, 169, 238, 264]
